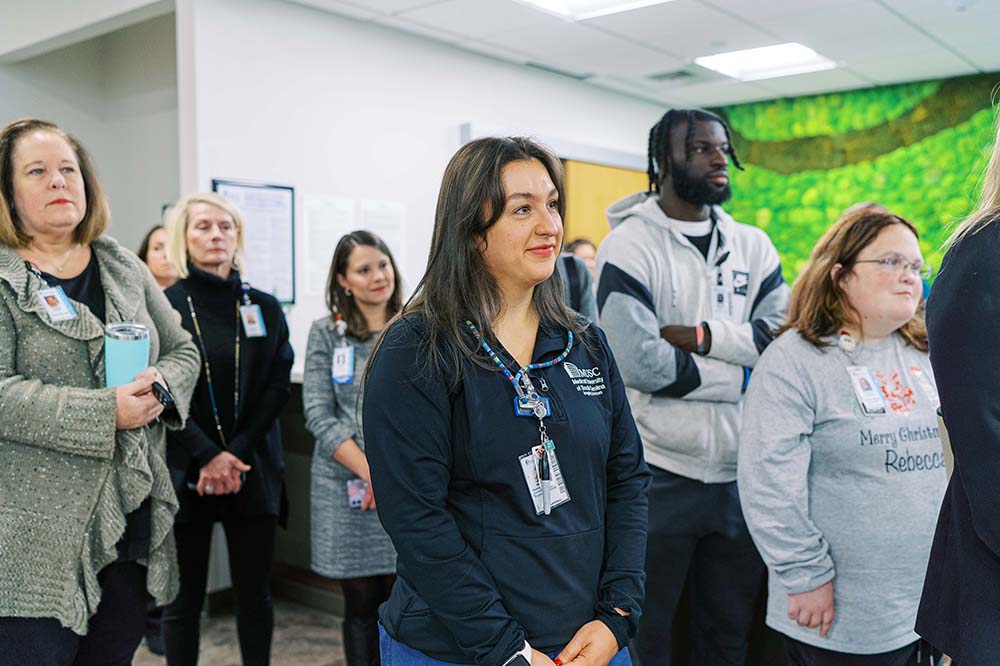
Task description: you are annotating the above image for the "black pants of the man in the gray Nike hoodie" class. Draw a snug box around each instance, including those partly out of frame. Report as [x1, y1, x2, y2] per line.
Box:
[633, 466, 764, 666]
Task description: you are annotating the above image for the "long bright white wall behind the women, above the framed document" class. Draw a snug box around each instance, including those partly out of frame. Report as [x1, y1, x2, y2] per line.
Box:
[187, 0, 663, 369]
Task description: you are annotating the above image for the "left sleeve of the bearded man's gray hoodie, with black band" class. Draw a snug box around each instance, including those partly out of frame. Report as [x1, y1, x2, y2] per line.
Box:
[597, 237, 745, 402]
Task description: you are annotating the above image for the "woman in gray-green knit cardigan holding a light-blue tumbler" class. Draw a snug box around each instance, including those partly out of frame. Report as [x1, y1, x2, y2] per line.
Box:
[0, 120, 199, 666]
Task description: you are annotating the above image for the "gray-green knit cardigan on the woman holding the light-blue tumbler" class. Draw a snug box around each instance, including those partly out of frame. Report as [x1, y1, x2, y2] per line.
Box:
[0, 237, 200, 635]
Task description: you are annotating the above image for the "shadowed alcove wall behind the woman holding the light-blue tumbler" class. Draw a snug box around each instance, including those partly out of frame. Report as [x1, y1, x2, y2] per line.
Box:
[0, 15, 179, 250]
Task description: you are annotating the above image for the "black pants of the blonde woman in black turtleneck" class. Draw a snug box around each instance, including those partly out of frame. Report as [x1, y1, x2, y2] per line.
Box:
[163, 516, 277, 666]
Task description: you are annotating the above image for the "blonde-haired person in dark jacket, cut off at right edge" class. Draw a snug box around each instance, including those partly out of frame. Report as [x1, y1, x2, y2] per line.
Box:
[917, 111, 1000, 666]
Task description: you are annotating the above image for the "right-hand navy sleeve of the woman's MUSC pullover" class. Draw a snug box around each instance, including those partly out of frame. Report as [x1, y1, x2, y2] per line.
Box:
[595, 324, 652, 648]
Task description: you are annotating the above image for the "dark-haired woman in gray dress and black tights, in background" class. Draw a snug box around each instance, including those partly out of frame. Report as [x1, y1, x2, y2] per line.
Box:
[302, 231, 402, 666]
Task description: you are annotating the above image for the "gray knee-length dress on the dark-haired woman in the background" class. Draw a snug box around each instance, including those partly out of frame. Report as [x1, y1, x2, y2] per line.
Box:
[302, 317, 396, 579]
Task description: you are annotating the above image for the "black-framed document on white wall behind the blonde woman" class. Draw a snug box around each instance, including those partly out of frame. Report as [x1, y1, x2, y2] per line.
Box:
[212, 178, 295, 304]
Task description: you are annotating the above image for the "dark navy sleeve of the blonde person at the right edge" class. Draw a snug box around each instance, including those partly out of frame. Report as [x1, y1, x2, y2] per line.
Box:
[927, 226, 1000, 557]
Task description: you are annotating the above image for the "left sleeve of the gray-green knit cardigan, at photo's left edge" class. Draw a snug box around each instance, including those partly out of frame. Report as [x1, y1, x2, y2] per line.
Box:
[0, 299, 116, 459]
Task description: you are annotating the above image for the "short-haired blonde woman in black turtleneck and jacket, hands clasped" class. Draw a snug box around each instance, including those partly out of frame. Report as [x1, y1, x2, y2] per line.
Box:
[163, 193, 294, 666]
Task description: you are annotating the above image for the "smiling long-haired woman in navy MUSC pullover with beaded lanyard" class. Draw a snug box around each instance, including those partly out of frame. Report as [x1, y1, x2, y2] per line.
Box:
[363, 138, 649, 666]
